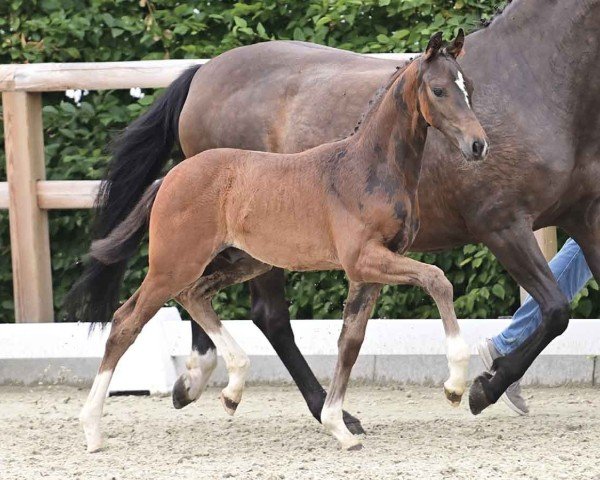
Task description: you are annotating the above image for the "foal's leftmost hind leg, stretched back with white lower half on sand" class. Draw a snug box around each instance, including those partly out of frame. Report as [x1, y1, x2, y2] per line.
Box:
[79, 277, 169, 452]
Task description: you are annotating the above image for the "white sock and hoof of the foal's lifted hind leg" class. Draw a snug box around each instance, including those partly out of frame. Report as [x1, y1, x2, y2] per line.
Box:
[207, 326, 250, 415]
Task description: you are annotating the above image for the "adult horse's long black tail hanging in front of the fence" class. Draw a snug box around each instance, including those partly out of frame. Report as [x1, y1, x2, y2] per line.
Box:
[64, 65, 200, 323]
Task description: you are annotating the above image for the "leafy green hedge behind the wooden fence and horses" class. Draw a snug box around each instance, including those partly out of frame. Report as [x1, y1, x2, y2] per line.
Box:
[0, 0, 600, 322]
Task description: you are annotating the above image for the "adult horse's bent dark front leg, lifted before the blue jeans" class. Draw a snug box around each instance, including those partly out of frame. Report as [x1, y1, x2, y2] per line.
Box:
[469, 225, 569, 415]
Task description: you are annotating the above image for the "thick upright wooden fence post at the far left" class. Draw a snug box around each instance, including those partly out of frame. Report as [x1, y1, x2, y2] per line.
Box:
[2, 92, 54, 322]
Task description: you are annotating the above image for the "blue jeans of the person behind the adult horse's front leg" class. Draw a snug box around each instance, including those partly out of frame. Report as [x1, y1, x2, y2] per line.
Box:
[492, 238, 592, 356]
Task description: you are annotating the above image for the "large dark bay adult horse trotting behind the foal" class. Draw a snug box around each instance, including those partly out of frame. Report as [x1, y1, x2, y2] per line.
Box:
[70, 0, 600, 431]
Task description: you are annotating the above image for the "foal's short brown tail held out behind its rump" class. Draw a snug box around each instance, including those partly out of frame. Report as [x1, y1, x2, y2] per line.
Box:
[90, 178, 163, 265]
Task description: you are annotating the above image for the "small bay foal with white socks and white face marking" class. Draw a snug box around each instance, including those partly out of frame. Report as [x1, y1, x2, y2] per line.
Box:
[80, 31, 487, 451]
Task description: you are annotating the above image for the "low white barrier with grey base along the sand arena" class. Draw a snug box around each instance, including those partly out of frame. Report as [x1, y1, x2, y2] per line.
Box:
[0, 308, 600, 391]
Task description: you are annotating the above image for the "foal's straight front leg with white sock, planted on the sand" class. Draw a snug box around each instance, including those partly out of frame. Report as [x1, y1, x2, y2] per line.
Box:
[321, 282, 382, 450]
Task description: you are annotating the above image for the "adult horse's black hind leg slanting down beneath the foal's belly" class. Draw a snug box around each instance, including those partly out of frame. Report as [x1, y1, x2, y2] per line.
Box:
[250, 268, 365, 434]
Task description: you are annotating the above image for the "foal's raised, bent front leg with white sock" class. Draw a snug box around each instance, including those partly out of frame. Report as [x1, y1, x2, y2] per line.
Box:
[354, 243, 471, 406]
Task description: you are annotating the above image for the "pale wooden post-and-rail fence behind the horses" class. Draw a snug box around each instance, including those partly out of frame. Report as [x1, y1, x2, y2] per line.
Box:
[0, 58, 556, 322]
